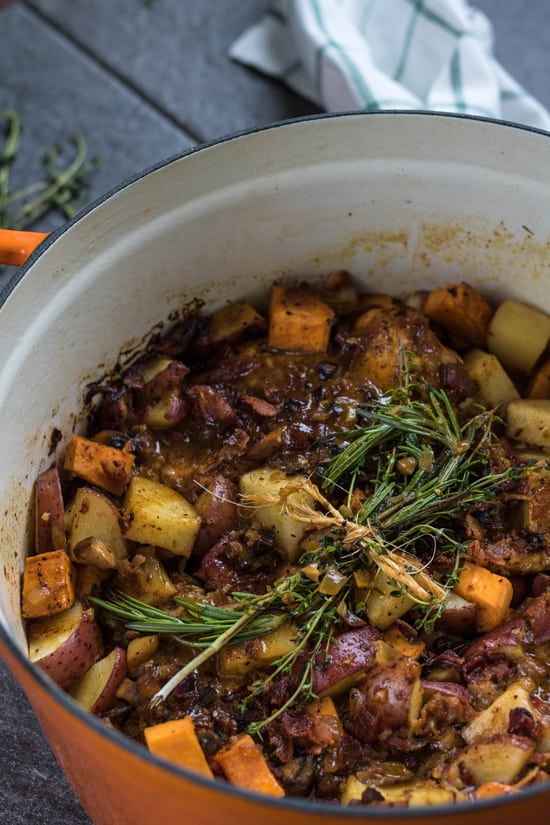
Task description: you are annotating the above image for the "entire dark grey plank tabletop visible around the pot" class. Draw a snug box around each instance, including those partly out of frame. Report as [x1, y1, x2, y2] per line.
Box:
[0, 0, 550, 825]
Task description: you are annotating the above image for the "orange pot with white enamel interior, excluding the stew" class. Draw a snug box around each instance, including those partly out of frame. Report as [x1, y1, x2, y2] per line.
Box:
[0, 113, 550, 825]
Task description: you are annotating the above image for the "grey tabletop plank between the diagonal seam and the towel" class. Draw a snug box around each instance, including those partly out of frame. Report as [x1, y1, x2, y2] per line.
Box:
[24, 0, 318, 141]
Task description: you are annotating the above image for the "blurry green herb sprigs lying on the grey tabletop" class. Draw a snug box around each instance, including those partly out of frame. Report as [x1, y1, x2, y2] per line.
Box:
[0, 109, 100, 229]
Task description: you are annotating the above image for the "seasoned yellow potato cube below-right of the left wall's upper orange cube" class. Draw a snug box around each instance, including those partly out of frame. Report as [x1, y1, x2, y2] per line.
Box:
[123, 476, 201, 557]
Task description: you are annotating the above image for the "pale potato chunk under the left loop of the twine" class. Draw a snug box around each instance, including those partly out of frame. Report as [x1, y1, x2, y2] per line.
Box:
[239, 467, 315, 562]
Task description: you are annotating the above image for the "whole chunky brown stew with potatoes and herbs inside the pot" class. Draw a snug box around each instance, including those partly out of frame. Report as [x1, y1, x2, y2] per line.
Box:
[22, 271, 550, 807]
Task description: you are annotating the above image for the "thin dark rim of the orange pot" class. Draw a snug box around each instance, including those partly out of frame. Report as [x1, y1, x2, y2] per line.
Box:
[0, 109, 550, 823]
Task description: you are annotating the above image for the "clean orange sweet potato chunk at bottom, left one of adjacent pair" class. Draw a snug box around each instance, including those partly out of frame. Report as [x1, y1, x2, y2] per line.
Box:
[143, 716, 212, 777]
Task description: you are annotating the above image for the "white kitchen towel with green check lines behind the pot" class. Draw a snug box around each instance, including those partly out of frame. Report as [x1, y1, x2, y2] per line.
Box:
[230, 0, 550, 130]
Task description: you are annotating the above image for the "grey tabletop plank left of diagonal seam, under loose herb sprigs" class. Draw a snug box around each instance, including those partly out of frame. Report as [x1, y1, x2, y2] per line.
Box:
[0, 4, 195, 285]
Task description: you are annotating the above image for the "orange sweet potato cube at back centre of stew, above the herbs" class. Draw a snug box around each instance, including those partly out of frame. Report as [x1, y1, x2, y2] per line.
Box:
[268, 285, 334, 352]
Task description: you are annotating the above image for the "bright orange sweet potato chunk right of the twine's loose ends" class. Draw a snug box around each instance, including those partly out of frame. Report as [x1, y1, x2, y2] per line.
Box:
[453, 562, 513, 633]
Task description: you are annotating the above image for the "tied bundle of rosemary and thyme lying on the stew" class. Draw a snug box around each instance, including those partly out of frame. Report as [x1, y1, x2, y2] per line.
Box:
[93, 378, 517, 733]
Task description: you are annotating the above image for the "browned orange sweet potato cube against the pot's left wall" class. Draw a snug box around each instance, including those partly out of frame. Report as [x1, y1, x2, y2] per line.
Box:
[21, 550, 75, 619]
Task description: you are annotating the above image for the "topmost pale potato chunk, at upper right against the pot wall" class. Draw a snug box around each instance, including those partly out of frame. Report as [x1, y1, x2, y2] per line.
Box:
[487, 300, 550, 374]
